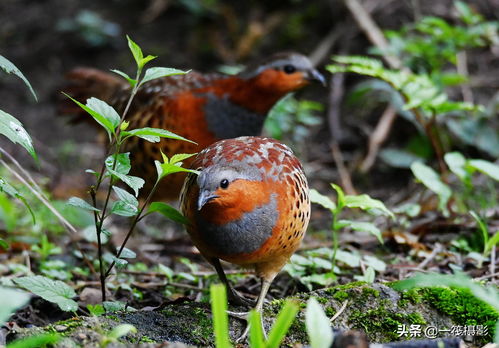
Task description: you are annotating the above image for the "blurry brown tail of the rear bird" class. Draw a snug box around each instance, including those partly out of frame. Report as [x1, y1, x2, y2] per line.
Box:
[58, 68, 128, 122]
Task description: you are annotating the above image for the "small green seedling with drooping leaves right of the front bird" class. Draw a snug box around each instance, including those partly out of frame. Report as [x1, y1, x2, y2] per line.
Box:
[310, 184, 394, 278]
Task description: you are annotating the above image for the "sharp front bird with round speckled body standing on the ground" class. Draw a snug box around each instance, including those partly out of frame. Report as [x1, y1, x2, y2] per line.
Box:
[180, 136, 310, 338]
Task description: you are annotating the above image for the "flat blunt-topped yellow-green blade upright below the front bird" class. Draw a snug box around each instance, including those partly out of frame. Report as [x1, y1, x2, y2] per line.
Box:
[210, 284, 231, 348]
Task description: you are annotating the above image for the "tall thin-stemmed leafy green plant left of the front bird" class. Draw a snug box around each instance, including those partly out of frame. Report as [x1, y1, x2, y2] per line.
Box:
[68, 37, 195, 301]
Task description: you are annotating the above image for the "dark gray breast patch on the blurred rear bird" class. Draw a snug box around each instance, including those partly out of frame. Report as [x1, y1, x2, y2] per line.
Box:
[203, 93, 265, 139]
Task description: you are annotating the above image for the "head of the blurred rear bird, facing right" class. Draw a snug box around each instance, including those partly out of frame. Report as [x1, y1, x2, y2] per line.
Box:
[240, 52, 326, 95]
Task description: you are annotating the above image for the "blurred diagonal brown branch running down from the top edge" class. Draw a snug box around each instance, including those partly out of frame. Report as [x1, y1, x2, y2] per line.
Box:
[344, 0, 402, 69]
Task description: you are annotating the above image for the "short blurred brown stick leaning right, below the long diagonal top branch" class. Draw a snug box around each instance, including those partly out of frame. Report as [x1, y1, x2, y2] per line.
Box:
[360, 105, 397, 173]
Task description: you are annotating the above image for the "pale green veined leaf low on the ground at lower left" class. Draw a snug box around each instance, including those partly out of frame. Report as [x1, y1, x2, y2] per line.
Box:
[14, 276, 78, 312]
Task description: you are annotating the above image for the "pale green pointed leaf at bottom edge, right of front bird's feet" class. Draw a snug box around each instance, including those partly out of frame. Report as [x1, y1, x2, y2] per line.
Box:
[305, 297, 333, 348]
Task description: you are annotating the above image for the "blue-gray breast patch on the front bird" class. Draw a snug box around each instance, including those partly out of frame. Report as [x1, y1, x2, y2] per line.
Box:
[196, 194, 278, 255]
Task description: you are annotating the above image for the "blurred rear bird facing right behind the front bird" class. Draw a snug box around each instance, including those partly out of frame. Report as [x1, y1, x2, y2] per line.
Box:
[59, 52, 325, 201]
